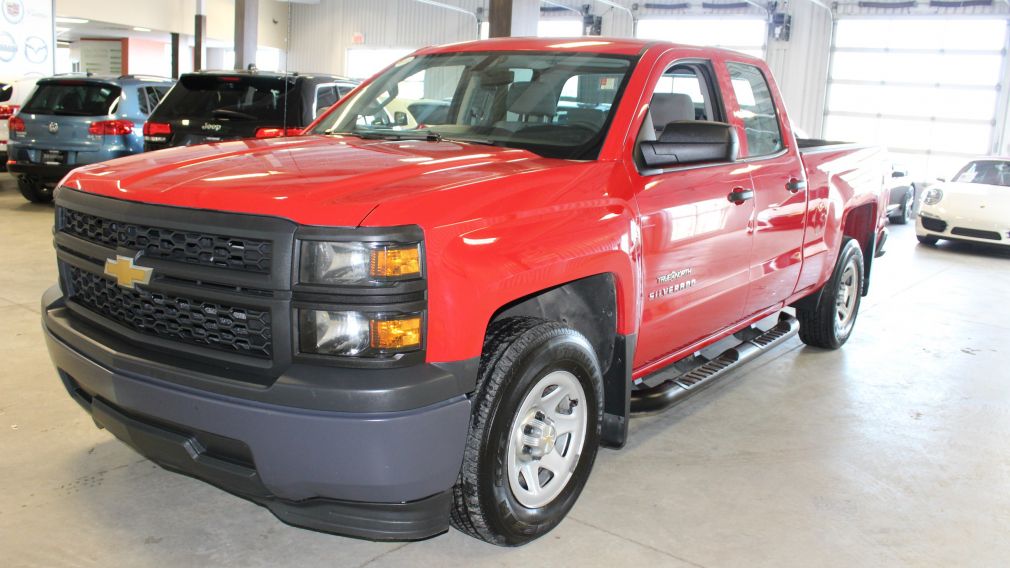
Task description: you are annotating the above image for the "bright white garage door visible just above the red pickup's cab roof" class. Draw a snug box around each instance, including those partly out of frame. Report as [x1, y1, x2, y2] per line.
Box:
[637, 17, 768, 59]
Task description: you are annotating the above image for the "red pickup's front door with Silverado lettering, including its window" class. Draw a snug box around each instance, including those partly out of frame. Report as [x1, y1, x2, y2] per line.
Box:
[632, 60, 754, 369]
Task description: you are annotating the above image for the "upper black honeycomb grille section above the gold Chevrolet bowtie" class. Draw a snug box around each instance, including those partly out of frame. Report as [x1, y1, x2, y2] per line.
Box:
[57, 207, 273, 274]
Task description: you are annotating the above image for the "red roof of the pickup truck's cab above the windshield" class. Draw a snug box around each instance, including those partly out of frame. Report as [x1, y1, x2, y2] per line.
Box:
[417, 36, 749, 57]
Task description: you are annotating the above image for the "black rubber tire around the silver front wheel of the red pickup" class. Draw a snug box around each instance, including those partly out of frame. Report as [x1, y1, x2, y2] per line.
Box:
[450, 317, 603, 546]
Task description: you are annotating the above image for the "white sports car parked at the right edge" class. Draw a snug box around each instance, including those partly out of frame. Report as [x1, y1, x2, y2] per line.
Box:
[915, 158, 1010, 246]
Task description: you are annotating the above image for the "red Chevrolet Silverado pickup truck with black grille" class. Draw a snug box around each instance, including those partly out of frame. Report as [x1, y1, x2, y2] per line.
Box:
[42, 37, 887, 545]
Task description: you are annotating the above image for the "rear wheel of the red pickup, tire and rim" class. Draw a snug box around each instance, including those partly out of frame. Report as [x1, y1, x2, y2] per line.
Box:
[796, 236, 864, 349]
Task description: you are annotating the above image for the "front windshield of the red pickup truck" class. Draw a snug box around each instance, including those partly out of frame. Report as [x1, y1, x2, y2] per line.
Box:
[312, 52, 634, 160]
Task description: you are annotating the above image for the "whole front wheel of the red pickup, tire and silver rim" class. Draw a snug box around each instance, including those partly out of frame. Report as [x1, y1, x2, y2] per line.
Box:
[451, 317, 603, 546]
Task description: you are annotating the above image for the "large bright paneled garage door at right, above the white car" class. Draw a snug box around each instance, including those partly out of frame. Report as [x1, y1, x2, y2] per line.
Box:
[824, 18, 1007, 179]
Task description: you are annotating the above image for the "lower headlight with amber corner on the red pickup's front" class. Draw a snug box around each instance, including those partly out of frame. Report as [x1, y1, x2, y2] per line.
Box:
[298, 309, 422, 357]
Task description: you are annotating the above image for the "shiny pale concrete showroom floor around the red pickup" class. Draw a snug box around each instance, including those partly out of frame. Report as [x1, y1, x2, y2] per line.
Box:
[0, 175, 1010, 568]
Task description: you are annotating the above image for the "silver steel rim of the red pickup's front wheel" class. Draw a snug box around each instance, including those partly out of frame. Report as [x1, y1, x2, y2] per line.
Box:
[506, 371, 588, 508]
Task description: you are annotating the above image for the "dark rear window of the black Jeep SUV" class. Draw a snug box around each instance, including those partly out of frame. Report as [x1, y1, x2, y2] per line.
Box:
[151, 75, 299, 122]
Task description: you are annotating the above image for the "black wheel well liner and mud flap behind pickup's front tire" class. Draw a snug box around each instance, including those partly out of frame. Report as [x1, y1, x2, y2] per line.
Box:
[488, 273, 635, 448]
